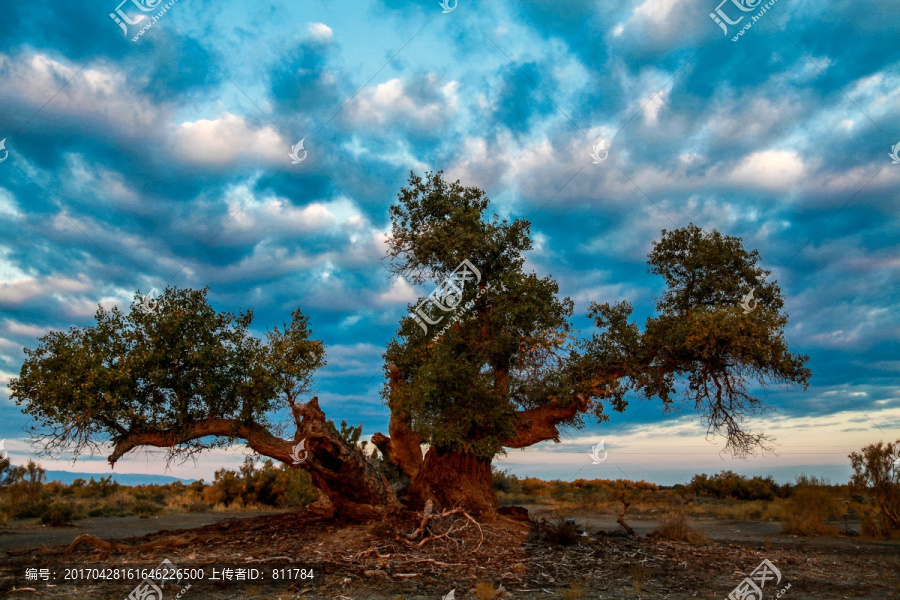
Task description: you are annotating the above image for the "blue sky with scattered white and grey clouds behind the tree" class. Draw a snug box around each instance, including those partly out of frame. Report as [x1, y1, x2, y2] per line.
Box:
[0, 0, 900, 483]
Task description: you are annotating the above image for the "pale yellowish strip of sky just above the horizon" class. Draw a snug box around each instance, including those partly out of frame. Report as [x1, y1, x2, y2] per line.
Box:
[6, 408, 900, 481]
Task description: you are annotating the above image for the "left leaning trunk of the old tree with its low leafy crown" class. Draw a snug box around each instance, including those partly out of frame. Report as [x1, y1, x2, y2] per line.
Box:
[9, 288, 398, 519]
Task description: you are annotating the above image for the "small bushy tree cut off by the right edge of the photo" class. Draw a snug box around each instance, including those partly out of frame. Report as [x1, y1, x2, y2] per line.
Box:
[850, 440, 900, 538]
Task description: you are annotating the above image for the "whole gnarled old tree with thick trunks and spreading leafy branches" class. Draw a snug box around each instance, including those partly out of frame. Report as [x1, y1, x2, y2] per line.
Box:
[10, 172, 810, 520]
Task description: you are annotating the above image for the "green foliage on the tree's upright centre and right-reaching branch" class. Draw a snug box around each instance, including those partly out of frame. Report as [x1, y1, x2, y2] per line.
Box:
[384, 172, 810, 458]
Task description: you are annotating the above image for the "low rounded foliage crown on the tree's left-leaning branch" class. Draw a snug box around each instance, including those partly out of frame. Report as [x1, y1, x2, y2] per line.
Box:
[10, 288, 325, 455]
